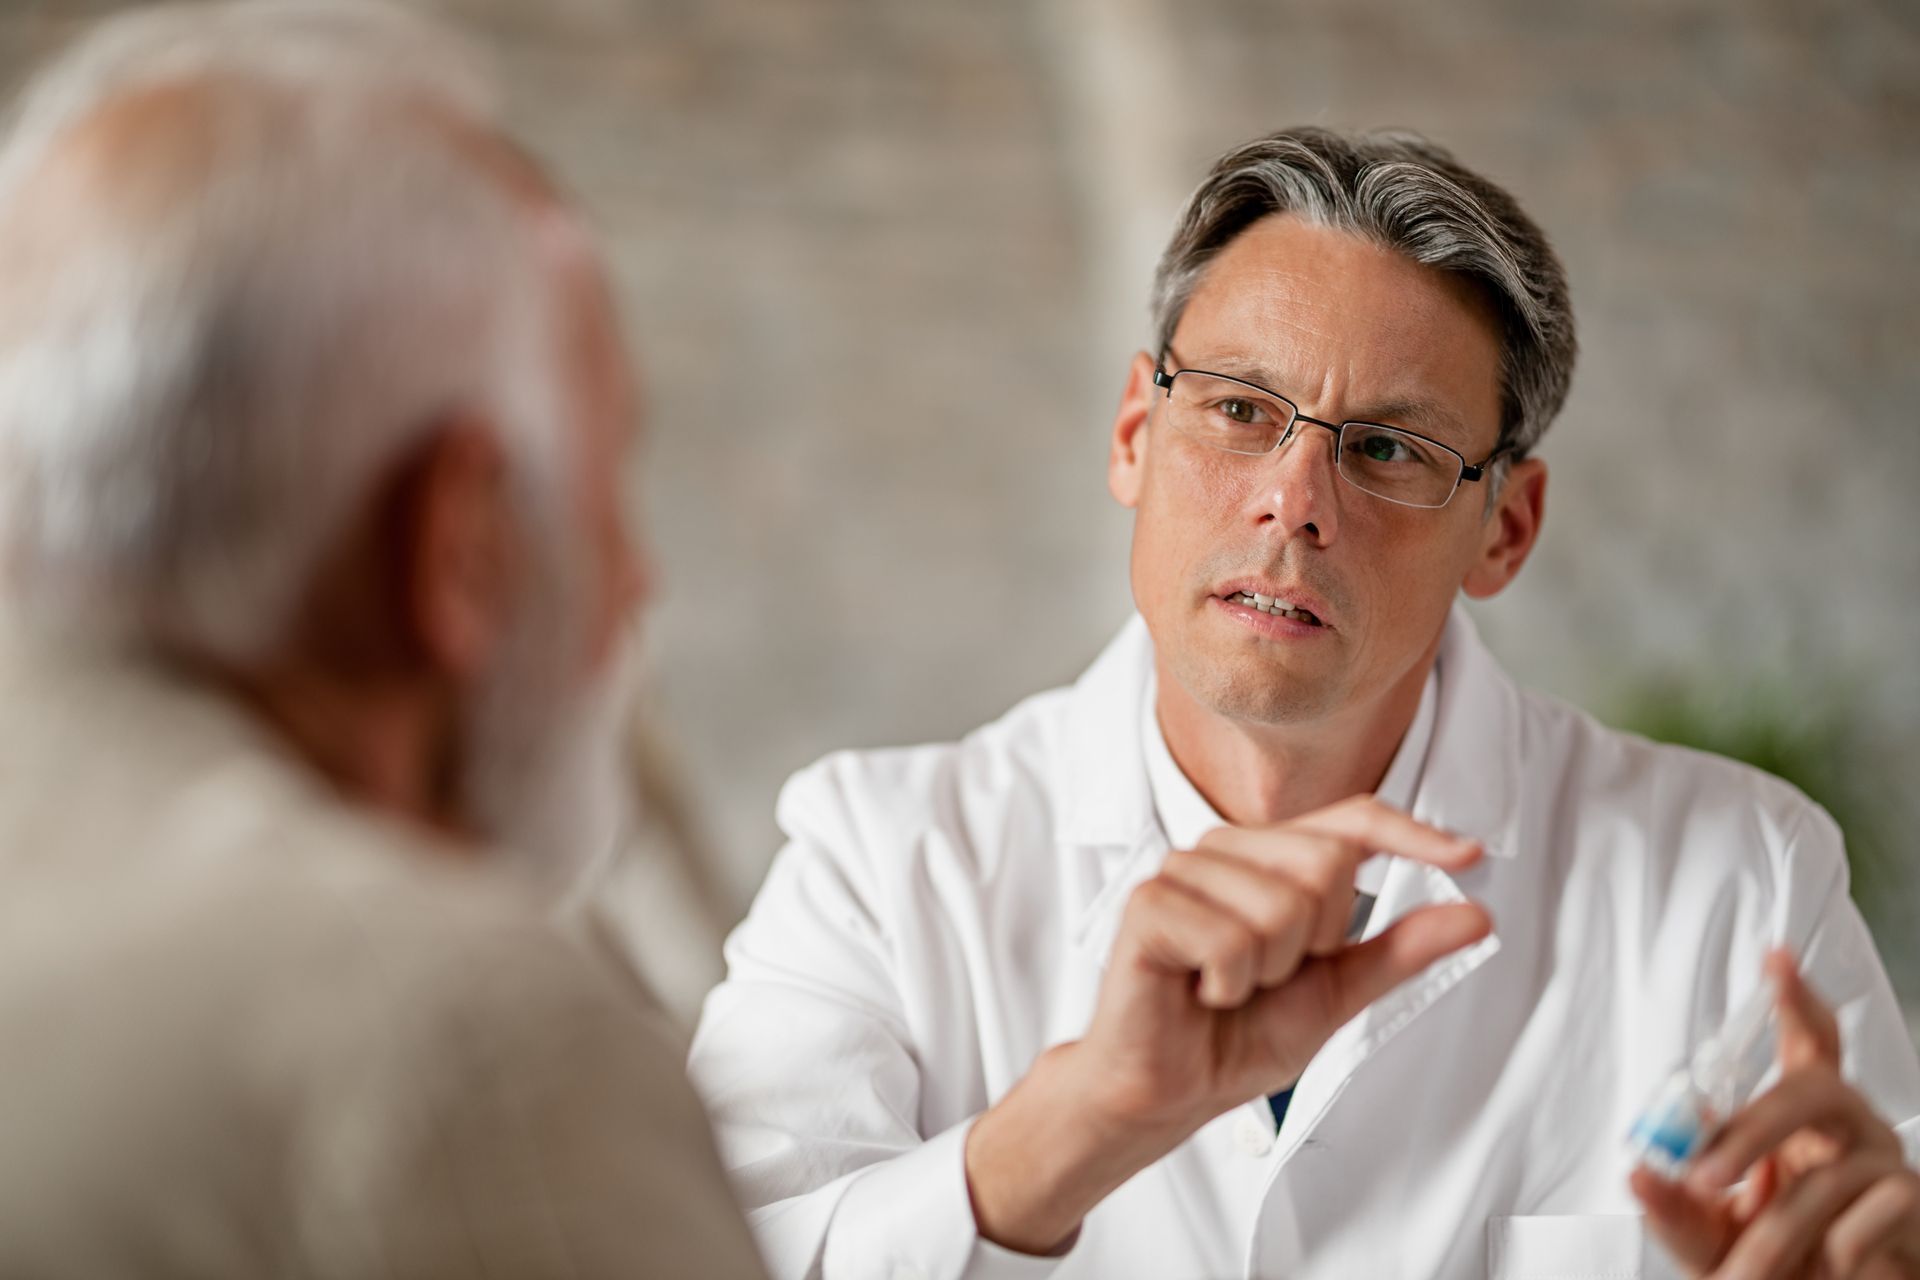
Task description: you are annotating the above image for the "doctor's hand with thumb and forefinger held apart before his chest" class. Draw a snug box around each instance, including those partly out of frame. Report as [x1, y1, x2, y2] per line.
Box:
[966, 796, 1492, 1253]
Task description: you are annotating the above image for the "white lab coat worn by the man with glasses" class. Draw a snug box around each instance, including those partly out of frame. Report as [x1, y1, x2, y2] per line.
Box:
[691, 612, 1920, 1280]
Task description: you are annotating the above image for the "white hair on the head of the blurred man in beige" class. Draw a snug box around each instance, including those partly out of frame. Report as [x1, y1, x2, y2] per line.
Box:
[0, 0, 564, 660]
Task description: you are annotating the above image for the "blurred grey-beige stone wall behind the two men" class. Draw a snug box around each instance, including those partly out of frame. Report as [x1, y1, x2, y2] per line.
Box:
[0, 0, 1920, 994]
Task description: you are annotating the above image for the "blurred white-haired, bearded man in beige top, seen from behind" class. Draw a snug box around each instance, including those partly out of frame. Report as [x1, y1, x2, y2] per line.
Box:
[0, 4, 762, 1280]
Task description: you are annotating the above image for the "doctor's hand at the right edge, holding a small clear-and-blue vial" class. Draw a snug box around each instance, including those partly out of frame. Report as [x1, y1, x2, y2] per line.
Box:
[1632, 950, 1920, 1280]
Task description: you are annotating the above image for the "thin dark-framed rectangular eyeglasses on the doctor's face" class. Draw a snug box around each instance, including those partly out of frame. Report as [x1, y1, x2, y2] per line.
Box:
[1154, 360, 1511, 507]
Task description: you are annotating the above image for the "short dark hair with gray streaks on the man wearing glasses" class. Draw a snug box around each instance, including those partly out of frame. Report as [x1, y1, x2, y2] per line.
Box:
[1152, 129, 1576, 457]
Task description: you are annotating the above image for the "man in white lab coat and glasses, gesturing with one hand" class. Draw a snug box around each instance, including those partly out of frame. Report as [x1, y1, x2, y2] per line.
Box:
[693, 129, 1920, 1280]
